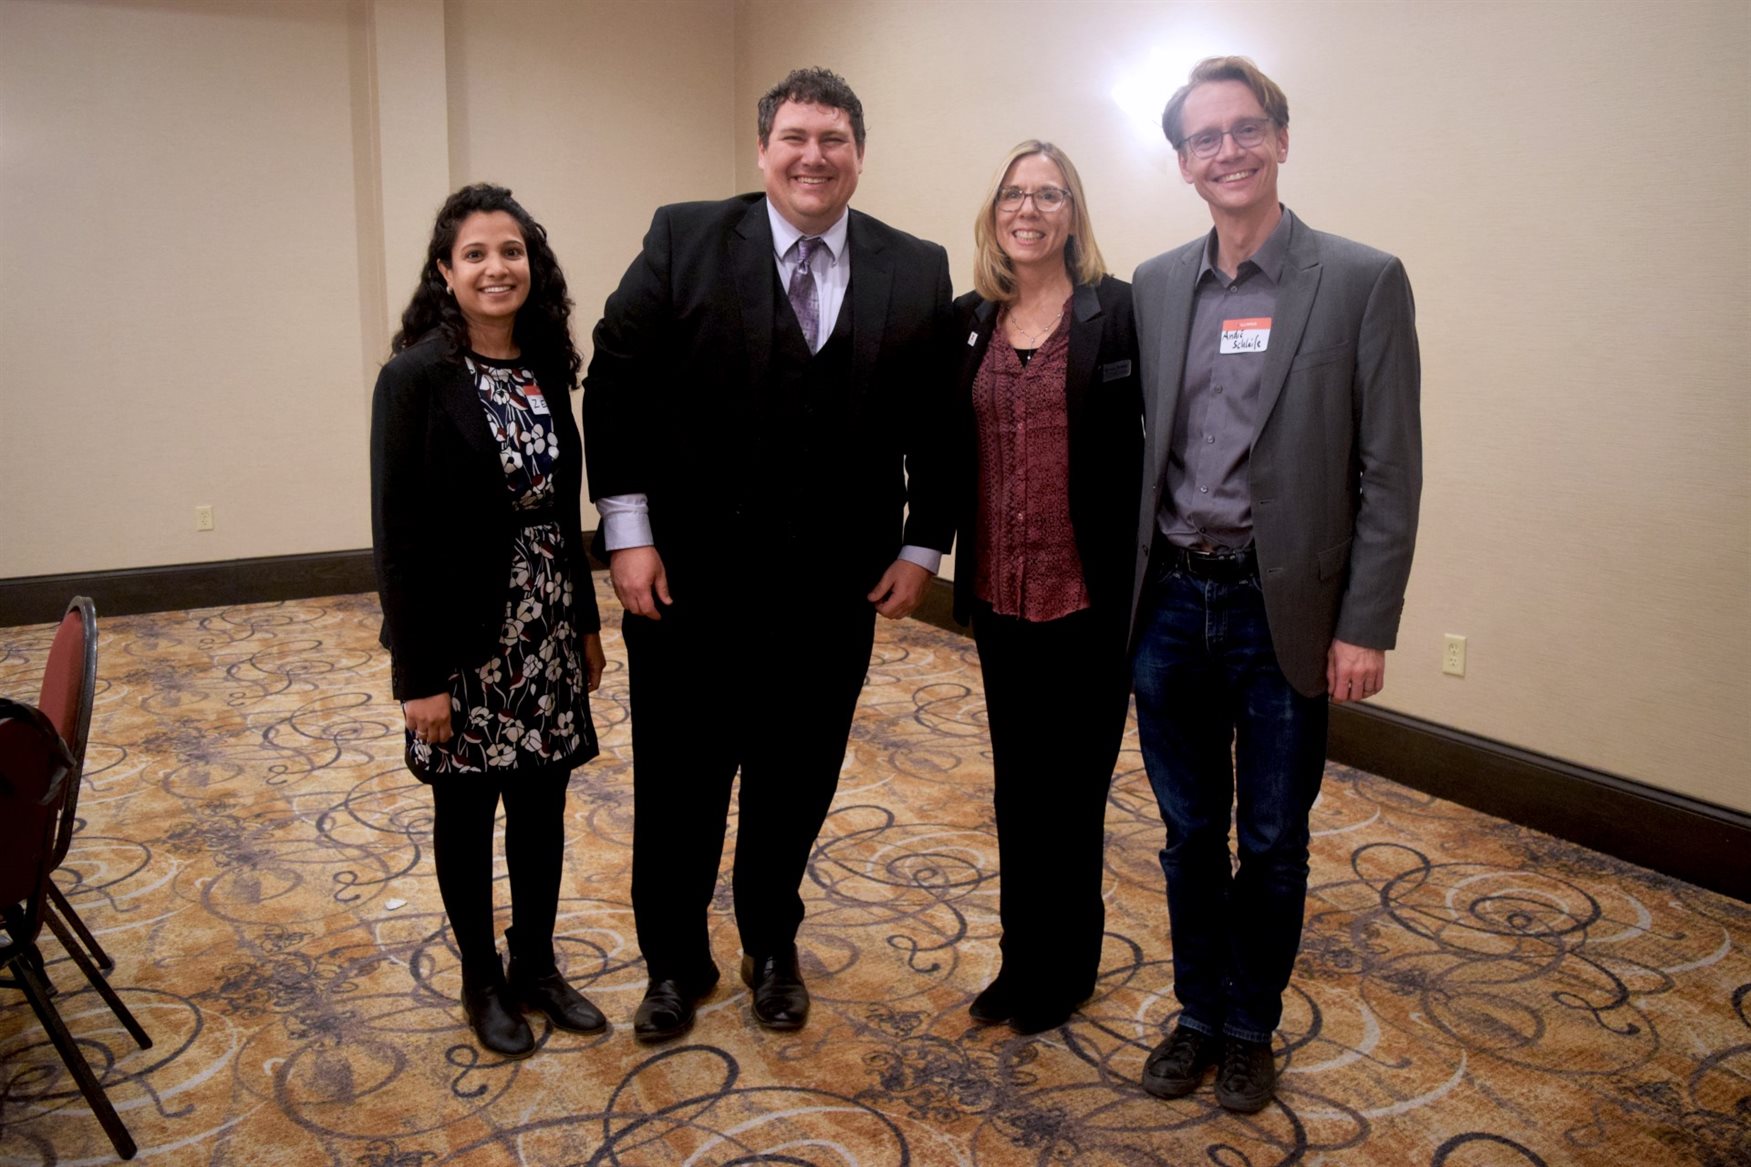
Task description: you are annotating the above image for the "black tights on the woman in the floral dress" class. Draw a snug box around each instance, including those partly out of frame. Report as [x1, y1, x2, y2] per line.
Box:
[431, 767, 571, 974]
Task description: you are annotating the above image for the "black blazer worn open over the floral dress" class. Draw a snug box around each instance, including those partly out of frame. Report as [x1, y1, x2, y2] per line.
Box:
[371, 335, 601, 701]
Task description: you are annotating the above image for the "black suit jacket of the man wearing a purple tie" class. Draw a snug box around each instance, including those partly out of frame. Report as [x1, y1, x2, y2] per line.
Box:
[583, 195, 954, 601]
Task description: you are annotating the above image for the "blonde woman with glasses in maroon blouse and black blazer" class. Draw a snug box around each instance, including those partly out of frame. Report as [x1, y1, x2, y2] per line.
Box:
[954, 140, 1143, 1034]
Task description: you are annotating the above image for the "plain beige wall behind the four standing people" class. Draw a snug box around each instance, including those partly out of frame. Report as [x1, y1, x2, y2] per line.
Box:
[0, 0, 1751, 810]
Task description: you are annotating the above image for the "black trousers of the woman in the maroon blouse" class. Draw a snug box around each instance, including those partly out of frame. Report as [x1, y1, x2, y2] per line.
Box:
[974, 605, 1131, 1004]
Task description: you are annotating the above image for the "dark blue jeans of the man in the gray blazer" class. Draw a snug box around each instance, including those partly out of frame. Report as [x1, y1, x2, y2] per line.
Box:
[1135, 557, 1327, 1041]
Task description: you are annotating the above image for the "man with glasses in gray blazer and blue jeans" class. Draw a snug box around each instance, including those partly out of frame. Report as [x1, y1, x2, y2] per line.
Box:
[1133, 56, 1422, 1113]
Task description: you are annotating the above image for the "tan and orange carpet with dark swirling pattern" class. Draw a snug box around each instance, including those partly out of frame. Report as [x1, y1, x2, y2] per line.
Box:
[0, 580, 1751, 1167]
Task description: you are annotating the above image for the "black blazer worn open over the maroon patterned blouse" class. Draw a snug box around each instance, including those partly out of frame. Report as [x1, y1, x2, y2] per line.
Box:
[954, 275, 1143, 636]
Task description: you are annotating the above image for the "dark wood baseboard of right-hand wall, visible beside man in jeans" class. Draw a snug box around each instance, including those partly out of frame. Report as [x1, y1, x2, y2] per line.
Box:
[914, 580, 1751, 902]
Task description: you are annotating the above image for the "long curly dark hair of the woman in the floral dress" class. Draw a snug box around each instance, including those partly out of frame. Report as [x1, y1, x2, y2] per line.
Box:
[389, 182, 583, 387]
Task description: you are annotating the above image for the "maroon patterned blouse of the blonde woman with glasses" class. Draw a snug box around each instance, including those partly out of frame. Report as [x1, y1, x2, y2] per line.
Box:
[974, 303, 1089, 622]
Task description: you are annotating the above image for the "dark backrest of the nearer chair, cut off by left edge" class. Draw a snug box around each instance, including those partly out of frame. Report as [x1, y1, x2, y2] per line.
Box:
[0, 697, 74, 953]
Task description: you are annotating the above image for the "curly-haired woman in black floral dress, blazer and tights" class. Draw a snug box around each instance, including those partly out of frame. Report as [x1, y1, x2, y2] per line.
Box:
[371, 184, 606, 1057]
